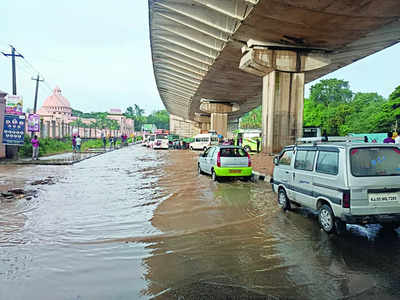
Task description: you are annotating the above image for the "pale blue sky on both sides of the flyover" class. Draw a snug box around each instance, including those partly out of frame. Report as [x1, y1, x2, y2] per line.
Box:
[0, 0, 400, 113]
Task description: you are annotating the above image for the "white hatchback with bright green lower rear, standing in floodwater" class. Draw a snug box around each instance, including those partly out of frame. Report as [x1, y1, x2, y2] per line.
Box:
[197, 145, 253, 181]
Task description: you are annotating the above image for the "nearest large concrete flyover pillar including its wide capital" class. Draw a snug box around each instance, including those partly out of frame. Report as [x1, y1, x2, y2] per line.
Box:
[239, 40, 330, 154]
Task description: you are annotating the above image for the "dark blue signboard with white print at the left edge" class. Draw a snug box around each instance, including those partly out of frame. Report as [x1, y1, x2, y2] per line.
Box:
[3, 115, 25, 146]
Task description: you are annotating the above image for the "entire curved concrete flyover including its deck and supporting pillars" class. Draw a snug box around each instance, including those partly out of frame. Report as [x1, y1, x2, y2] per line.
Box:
[148, 0, 400, 153]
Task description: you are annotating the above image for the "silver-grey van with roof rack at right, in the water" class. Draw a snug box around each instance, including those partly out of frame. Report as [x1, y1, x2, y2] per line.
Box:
[271, 138, 400, 233]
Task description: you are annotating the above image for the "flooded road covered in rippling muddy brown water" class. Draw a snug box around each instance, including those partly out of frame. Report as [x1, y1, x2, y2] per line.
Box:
[0, 146, 400, 299]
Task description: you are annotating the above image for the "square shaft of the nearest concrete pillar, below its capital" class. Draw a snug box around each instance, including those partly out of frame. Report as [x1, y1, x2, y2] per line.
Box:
[262, 71, 304, 154]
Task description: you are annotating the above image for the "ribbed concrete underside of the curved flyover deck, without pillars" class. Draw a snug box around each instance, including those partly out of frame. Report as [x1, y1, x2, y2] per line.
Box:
[149, 0, 400, 150]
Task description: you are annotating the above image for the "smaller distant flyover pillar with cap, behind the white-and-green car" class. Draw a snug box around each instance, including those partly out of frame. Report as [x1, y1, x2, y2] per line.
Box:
[200, 101, 239, 137]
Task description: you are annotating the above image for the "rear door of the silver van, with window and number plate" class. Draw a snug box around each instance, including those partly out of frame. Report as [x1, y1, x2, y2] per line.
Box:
[349, 145, 400, 215]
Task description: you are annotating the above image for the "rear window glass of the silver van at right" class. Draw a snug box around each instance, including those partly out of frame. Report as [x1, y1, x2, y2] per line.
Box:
[350, 147, 400, 177]
